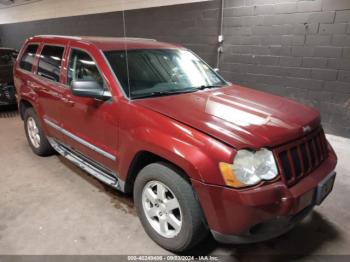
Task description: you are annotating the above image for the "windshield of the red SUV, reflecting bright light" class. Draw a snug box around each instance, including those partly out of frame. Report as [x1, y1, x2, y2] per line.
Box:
[105, 49, 226, 98]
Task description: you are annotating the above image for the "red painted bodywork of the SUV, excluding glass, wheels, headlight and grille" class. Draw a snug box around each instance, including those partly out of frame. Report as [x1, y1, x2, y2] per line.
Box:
[14, 37, 336, 237]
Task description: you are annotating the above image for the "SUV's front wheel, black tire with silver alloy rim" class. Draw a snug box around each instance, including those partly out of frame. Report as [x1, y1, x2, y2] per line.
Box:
[134, 163, 209, 252]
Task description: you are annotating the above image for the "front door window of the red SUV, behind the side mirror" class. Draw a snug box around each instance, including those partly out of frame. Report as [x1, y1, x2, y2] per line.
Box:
[68, 49, 104, 87]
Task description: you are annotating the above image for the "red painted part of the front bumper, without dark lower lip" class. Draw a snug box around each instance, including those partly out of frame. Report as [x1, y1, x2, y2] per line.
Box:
[192, 153, 337, 235]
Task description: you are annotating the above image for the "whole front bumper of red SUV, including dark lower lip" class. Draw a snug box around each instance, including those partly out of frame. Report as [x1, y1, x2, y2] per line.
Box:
[192, 153, 337, 243]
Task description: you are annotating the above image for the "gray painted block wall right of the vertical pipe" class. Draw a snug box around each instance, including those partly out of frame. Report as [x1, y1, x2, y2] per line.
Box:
[222, 0, 350, 137]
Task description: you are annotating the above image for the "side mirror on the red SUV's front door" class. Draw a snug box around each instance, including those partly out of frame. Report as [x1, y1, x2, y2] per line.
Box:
[72, 81, 111, 101]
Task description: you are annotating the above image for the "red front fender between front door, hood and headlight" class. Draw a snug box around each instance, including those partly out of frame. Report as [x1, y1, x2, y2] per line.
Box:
[117, 101, 235, 185]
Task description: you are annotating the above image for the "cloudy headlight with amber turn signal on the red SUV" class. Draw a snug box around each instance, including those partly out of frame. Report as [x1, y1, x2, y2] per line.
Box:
[219, 148, 278, 187]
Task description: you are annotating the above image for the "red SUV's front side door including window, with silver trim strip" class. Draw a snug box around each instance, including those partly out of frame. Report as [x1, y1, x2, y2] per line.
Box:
[62, 47, 118, 171]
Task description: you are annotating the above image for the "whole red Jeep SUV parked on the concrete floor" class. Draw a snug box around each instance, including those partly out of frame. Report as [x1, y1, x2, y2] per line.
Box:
[14, 36, 337, 252]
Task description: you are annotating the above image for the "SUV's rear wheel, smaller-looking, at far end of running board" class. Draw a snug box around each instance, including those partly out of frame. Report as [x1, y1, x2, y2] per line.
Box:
[24, 108, 55, 156]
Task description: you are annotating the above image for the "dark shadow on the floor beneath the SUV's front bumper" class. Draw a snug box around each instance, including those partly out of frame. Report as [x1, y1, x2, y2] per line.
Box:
[190, 211, 341, 262]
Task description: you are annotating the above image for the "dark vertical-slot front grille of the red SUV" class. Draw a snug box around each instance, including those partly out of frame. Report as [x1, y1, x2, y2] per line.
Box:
[274, 128, 328, 185]
